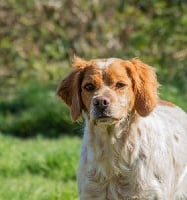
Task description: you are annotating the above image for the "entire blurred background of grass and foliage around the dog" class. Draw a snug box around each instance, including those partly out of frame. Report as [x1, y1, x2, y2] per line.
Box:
[0, 0, 187, 200]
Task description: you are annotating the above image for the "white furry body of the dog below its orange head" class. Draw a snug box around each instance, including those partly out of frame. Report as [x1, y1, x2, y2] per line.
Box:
[78, 105, 187, 200]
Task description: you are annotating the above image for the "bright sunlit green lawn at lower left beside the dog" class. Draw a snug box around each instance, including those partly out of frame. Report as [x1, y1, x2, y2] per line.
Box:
[0, 135, 80, 200]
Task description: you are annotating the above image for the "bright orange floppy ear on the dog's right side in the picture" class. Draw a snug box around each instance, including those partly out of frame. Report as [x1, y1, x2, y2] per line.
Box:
[127, 58, 159, 116]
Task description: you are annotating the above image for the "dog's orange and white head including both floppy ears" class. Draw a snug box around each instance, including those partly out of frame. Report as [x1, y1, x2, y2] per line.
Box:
[57, 57, 159, 122]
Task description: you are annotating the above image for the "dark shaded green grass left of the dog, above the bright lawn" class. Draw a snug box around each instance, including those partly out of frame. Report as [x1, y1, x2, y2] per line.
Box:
[0, 82, 82, 138]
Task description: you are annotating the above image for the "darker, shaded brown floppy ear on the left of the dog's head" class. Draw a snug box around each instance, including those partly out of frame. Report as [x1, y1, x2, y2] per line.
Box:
[57, 57, 88, 121]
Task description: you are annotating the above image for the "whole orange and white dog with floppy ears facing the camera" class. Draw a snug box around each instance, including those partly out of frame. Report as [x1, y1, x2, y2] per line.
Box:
[57, 57, 187, 200]
